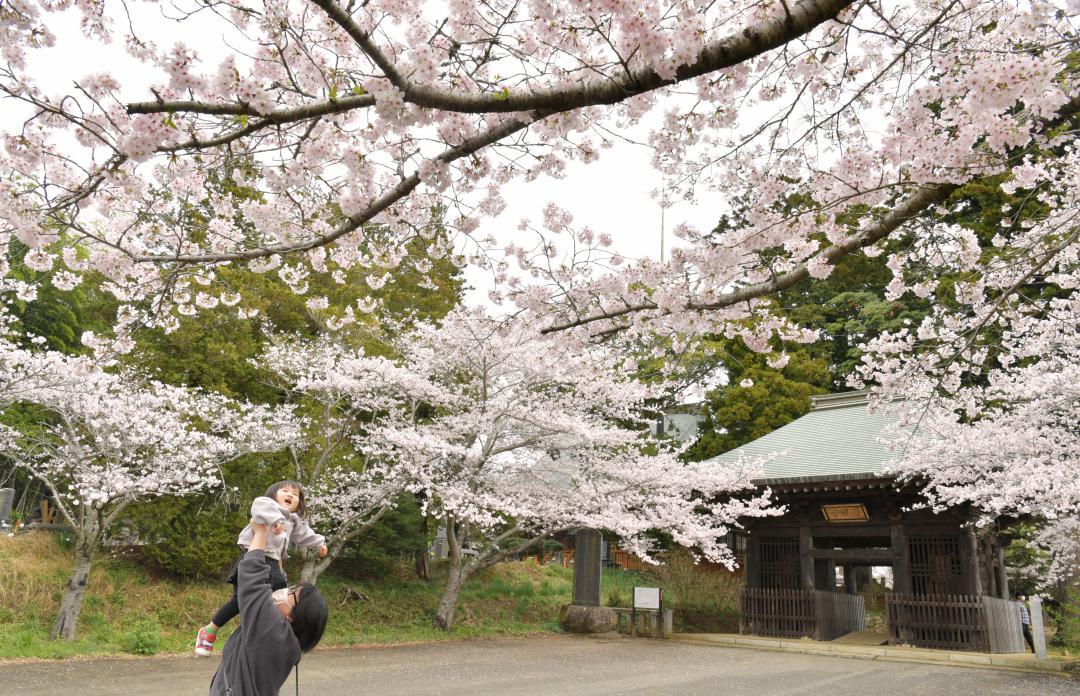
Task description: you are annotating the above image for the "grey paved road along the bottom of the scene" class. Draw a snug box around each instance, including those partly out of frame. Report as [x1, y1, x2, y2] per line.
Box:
[0, 637, 1080, 696]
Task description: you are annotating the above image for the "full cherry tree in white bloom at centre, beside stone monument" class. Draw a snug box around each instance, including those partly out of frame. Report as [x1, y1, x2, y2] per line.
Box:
[372, 310, 774, 630]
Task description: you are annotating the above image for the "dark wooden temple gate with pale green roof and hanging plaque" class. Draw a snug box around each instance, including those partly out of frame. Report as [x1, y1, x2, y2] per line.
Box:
[713, 392, 1023, 652]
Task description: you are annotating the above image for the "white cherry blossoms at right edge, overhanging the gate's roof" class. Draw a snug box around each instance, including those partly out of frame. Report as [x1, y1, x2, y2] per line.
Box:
[855, 147, 1080, 538]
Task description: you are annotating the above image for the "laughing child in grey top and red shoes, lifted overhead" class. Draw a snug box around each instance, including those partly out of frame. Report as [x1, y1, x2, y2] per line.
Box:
[195, 481, 326, 657]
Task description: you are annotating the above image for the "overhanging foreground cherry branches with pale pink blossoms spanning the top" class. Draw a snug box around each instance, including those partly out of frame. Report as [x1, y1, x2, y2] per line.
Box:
[0, 0, 1080, 583]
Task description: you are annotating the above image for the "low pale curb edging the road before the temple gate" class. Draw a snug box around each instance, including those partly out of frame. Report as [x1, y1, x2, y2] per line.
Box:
[671, 633, 1072, 679]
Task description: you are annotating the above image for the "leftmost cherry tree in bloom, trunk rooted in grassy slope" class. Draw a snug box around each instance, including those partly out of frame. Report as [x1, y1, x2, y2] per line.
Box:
[0, 352, 300, 640]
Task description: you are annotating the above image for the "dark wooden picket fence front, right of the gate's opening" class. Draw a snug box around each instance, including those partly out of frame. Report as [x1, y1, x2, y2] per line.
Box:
[886, 593, 990, 653]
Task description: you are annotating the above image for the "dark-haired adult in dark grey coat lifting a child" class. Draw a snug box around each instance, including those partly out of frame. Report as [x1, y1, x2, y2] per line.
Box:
[210, 520, 326, 696]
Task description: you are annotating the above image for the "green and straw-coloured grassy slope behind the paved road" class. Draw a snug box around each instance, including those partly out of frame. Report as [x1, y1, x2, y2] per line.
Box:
[0, 533, 646, 658]
